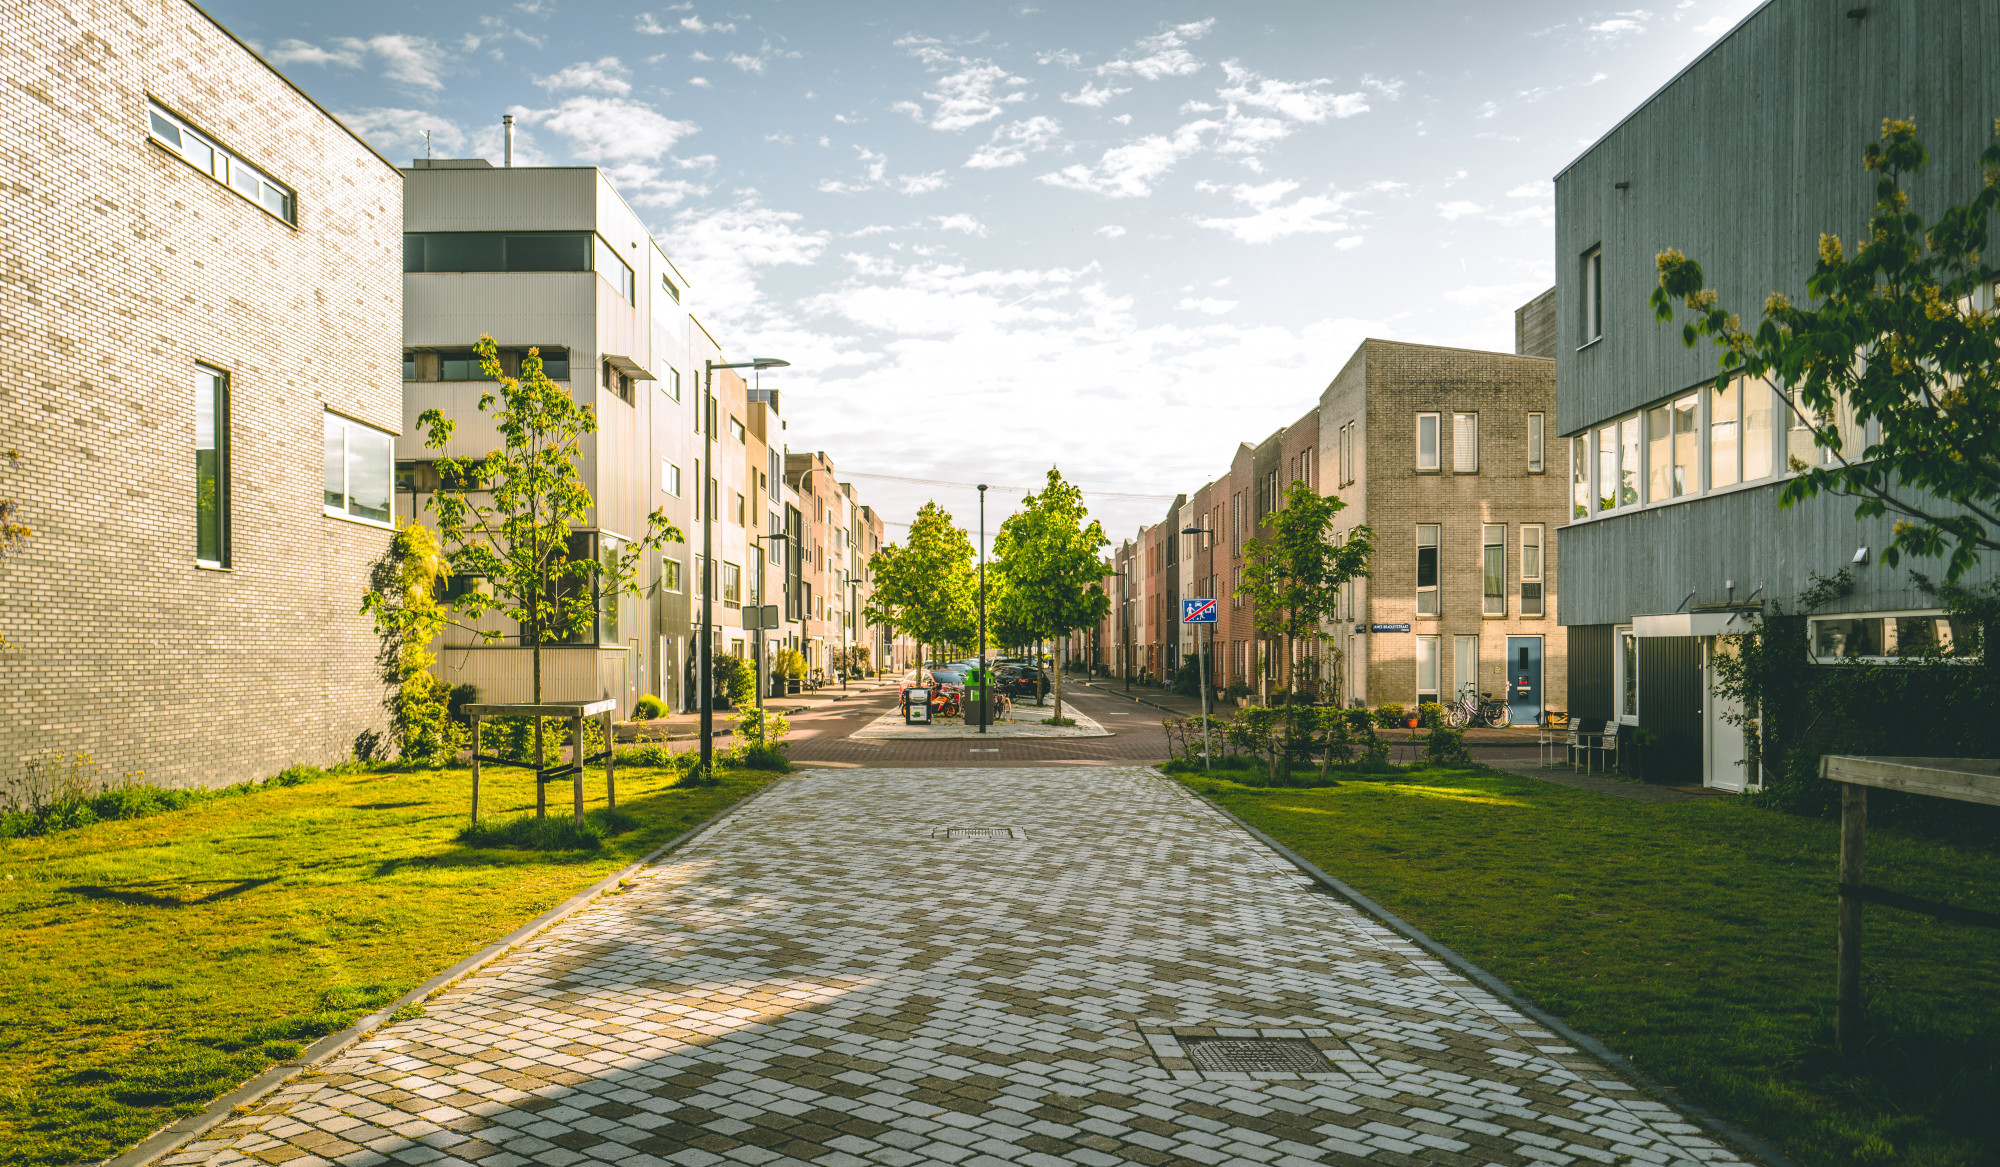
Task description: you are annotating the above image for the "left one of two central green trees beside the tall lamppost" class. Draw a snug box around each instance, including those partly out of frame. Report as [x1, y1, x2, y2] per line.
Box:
[862, 502, 978, 669]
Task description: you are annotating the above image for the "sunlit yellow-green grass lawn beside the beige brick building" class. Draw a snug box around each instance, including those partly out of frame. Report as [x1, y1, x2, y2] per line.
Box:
[0, 755, 774, 1163]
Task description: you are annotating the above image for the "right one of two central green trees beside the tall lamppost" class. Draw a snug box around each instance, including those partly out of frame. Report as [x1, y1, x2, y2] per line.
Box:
[994, 466, 1112, 721]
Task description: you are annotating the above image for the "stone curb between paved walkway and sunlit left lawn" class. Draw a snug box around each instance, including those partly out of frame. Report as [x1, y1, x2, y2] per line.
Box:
[98, 775, 784, 1167]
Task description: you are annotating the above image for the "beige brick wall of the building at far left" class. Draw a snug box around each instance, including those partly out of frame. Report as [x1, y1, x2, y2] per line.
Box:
[0, 0, 402, 799]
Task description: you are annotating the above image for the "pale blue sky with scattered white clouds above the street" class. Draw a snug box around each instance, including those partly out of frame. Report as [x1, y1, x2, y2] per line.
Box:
[204, 0, 1756, 542]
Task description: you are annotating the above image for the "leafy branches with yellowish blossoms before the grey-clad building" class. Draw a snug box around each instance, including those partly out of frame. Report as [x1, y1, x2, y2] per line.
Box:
[1652, 120, 2000, 584]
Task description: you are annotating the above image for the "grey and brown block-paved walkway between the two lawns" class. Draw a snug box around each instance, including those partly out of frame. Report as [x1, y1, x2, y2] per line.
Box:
[184, 769, 1734, 1167]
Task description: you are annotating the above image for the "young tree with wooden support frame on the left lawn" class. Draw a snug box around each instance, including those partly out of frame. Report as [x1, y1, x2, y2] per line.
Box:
[418, 336, 682, 765]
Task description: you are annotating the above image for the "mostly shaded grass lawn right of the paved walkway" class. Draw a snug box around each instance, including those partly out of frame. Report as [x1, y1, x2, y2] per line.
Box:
[1184, 769, 2000, 1167]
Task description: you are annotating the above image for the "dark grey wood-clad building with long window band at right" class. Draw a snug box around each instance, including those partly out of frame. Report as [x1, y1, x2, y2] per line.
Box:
[1550, 0, 2000, 789]
